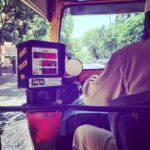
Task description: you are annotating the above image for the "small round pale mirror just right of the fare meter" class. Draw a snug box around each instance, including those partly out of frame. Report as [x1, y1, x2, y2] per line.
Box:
[65, 58, 83, 76]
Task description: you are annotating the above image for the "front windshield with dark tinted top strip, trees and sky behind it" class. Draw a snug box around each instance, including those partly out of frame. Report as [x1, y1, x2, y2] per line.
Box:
[60, 4, 144, 64]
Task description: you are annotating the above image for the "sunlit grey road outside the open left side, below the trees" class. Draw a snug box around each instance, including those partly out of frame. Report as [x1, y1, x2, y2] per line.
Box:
[0, 74, 32, 150]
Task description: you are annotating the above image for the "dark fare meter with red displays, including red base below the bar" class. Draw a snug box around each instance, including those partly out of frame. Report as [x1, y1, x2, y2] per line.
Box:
[17, 40, 65, 149]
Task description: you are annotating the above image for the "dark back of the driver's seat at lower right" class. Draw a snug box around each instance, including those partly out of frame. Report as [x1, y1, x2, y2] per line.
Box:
[109, 91, 150, 150]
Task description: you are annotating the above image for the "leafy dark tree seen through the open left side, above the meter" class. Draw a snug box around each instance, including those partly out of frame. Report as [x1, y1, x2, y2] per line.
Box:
[0, 0, 49, 44]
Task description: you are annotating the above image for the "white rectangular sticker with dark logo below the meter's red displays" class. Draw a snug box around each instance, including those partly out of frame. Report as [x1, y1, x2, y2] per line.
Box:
[29, 77, 62, 88]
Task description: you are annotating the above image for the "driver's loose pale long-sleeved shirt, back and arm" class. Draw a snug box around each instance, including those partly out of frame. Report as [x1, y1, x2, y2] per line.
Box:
[83, 40, 150, 105]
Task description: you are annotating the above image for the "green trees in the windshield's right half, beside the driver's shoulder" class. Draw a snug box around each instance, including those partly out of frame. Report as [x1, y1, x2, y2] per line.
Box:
[83, 13, 144, 60]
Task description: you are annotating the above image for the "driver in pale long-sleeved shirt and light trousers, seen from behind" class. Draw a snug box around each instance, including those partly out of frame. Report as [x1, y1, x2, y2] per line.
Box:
[73, 0, 150, 150]
